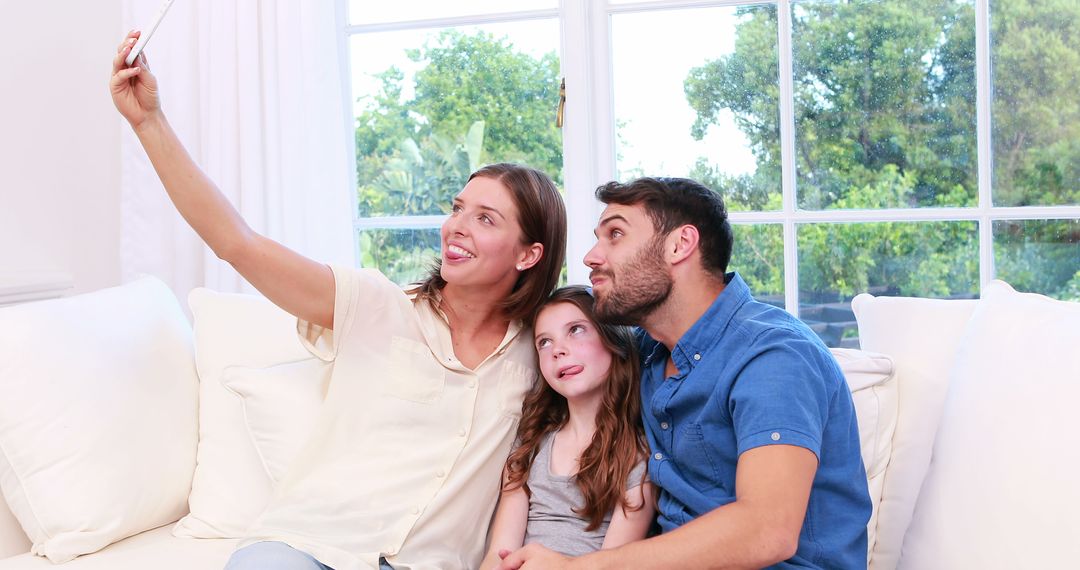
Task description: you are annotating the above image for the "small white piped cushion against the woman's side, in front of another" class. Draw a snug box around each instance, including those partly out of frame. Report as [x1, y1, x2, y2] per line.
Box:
[224, 356, 333, 484]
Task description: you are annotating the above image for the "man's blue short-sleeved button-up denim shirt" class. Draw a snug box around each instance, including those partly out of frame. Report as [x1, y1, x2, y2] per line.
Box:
[639, 273, 870, 569]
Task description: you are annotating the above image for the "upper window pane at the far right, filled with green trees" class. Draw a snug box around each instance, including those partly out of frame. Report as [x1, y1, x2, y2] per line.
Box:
[990, 0, 1080, 206]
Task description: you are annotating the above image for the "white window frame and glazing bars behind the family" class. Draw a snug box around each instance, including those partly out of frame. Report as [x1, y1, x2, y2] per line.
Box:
[337, 0, 1080, 315]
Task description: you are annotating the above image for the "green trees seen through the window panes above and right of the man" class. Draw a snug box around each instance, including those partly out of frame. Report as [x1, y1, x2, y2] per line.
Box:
[685, 0, 1080, 301]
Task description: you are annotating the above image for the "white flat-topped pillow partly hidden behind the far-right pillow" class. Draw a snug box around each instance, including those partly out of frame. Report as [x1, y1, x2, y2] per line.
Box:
[851, 294, 976, 570]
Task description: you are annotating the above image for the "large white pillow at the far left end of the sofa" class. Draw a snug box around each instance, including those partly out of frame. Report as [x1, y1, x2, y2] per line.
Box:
[0, 277, 198, 562]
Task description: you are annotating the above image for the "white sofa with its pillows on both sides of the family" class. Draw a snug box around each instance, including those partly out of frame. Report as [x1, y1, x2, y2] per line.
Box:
[0, 277, 1080, 570]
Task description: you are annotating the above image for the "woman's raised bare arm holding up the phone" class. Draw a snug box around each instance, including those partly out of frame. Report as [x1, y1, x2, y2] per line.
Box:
[109, 32, 335, 328]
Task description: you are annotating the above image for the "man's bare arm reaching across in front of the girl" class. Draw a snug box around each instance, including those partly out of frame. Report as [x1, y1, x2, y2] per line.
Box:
[499, 445, 818, 570]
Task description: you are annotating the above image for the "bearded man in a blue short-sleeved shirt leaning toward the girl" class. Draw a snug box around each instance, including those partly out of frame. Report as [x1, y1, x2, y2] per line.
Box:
[502, 178, 870, 570]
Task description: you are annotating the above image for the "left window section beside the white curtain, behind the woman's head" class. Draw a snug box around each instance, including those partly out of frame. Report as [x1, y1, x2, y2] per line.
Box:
[346, 0, 563, 284]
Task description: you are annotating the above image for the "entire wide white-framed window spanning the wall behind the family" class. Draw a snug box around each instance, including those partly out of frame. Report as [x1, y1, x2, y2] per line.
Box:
[346, 0, 1080, 345]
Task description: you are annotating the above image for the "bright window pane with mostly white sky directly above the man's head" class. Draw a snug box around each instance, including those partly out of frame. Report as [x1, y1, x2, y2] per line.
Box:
[611, 5, 781, 211]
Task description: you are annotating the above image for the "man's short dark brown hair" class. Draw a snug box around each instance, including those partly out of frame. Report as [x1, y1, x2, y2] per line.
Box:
[596, 177, 734, 279]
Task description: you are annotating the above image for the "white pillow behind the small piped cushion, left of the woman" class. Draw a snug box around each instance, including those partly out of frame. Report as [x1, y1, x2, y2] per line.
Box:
[173, 288, 319, 539]
